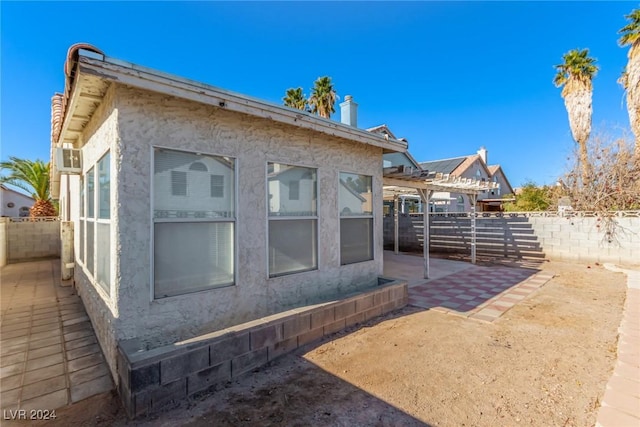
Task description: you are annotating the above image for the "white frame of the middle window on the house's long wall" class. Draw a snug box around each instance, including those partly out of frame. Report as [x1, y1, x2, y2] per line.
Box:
[264, 160, 320, 280]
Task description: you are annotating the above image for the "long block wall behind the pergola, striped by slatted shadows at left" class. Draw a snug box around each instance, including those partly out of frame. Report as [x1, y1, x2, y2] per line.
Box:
[384, 213, 640, 265]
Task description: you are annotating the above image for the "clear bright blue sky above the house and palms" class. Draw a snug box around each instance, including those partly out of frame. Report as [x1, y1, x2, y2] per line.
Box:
[0, 1, 638, 187]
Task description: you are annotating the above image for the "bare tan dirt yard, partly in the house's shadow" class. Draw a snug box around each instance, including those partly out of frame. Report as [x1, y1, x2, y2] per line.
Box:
[38, 262, 626, 426]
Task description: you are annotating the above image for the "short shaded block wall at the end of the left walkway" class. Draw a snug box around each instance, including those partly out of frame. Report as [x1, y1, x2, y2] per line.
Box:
[6, 220, 60, 263]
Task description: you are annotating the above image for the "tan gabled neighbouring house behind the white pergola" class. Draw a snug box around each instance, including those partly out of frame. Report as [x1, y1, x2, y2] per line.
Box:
[420, 147, 513, 212]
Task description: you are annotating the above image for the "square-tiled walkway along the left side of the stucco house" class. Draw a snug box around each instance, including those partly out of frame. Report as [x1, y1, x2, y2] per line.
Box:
[0, 259, 113, 413]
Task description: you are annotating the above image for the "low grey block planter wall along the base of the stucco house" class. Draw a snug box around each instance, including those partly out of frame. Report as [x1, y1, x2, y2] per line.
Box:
[118, 278, 408, 418]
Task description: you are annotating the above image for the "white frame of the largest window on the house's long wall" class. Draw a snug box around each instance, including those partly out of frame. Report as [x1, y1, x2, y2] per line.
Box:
[149, 145, 239, 302]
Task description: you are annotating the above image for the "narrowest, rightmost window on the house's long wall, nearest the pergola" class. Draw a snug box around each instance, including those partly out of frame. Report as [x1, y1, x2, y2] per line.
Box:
[338, 172, 373, 265]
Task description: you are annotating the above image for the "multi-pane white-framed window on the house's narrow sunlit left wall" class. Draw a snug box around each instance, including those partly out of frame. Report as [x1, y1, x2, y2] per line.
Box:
[80, 152, 111, 294]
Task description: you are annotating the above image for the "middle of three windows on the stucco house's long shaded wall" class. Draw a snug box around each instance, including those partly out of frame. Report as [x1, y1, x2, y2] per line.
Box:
[267, 163, 318, 277]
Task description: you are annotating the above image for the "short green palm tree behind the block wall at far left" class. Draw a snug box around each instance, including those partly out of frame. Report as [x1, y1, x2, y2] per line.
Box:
[0, 157, 57, 217]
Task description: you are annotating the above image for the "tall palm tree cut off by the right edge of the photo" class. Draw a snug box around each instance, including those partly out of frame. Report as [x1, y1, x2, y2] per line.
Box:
[618, 9, 640, 156]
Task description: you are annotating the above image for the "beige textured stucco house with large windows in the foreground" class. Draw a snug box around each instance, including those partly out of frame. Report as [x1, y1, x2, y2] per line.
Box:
[52, 46, 407, 381]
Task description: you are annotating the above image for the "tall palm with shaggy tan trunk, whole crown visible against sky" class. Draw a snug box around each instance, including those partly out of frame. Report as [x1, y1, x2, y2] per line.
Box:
[553, 49, 598, 185]
